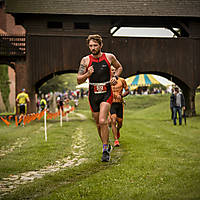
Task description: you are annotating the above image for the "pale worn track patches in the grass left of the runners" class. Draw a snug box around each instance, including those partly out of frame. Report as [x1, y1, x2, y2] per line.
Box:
[0, 113, 87, 198]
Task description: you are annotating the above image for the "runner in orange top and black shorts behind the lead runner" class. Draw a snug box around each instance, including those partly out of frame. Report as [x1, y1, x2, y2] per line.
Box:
[110, 66, 129, 147]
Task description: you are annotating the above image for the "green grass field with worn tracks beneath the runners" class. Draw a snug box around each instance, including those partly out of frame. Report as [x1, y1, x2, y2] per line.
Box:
[0, 95, 200, 200]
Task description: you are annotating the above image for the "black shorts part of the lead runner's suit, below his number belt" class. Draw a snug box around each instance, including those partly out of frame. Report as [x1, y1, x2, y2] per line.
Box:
[88, 85, 113, 112]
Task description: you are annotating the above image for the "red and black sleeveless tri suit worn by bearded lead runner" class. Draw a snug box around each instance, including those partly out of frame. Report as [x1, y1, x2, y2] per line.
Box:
[88, 53, 113, 112]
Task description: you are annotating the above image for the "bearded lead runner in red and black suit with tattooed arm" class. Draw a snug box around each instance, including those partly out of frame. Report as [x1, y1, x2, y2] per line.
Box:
[77, 35, 123, 162]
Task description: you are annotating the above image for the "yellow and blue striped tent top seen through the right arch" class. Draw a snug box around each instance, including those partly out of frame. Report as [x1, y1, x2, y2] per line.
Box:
[126, 74, 160, 90]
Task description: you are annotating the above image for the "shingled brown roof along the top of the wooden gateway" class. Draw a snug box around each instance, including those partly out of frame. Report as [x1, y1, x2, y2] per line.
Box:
[6, 0, 200, 17]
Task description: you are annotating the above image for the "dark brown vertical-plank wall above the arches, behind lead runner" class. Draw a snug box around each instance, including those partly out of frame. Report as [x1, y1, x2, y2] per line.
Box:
[28, 36, 200, 88]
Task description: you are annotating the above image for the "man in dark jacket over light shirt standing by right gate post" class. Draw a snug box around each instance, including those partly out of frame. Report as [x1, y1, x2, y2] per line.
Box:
[172, 87, 185, 125]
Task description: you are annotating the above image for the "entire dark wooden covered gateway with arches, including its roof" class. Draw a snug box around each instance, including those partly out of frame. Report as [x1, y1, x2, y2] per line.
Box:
[0, 0, 200, 115]
